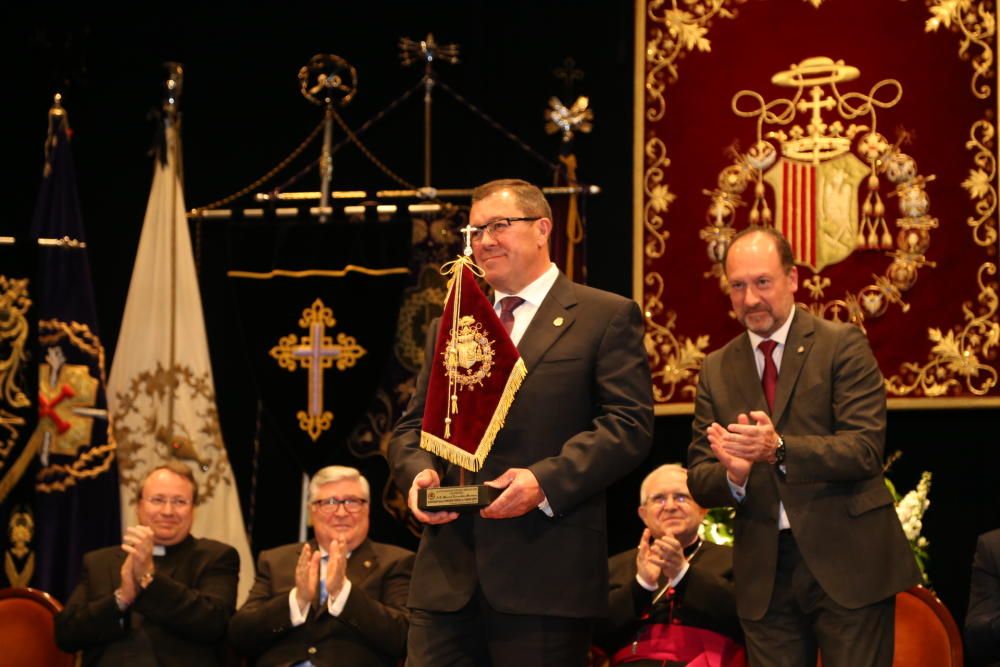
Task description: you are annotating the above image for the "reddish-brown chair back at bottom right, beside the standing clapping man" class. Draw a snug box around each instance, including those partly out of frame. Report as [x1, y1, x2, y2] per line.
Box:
[892, 586, 963, 667]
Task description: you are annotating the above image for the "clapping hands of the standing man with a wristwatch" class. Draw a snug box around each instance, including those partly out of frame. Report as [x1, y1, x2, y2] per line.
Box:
[706, 410, 778, 486]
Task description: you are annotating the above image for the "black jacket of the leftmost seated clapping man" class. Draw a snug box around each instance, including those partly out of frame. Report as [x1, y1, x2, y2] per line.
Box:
[55, 536, 240, 667]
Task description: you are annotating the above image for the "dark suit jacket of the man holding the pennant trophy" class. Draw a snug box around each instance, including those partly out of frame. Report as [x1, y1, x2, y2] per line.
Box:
[389, 274, 653, 618]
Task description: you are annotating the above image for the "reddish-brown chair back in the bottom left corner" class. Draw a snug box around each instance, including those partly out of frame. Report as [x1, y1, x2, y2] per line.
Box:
[0, 588, 76, 667]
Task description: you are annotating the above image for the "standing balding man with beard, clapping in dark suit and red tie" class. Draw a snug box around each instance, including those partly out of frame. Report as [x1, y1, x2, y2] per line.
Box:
[688, 227, 920, 667]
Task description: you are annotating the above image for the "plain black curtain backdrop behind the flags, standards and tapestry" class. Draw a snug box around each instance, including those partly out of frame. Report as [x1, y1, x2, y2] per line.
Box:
[0, 0, 1000, 622]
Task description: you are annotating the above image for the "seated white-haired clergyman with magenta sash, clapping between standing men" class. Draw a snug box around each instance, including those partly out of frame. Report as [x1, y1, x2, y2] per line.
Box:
[597, 464, 746, 667]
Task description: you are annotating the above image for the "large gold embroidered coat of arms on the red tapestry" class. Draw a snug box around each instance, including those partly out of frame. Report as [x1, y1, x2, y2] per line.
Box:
[700, 57, 938, 330]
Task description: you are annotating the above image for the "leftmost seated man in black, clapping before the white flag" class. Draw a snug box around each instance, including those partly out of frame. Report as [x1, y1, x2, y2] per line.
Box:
[55, 461, 240, 667]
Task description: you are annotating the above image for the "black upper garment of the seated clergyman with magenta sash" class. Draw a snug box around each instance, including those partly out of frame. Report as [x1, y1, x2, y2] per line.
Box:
[597, 542, 743, 656]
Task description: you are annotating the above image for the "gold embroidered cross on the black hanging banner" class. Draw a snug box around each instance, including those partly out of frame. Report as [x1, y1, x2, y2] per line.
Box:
[270, 299, 368, 442]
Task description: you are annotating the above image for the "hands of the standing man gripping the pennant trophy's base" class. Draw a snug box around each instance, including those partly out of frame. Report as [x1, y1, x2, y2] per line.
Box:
[407, 468, 545, 525]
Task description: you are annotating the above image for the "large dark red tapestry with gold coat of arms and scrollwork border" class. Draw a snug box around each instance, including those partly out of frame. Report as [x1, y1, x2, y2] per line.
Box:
[634, 0, 1000, 414]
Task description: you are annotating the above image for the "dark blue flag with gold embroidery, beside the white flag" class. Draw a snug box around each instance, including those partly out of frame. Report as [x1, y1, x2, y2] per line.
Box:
[28, 98, 121, 601]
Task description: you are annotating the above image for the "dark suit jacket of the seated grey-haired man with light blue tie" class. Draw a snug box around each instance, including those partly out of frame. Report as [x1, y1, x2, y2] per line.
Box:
[229, 540, 413, 667]
